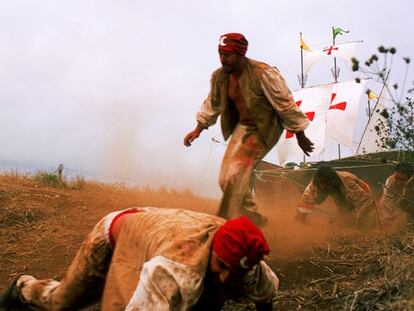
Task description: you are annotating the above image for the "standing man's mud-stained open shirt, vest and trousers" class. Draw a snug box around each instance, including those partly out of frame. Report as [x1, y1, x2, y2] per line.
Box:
[197, 58, 309, 221]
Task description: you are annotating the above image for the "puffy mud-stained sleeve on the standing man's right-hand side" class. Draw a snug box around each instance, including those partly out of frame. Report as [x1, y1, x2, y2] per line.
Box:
[261, 68, 309, 133]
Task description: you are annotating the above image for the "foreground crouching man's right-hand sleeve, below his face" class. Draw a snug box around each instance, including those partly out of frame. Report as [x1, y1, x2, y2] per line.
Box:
[243, 261, 279, 304]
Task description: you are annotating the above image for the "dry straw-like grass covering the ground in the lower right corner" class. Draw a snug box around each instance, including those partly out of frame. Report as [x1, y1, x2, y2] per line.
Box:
[272, 225, 414, 310]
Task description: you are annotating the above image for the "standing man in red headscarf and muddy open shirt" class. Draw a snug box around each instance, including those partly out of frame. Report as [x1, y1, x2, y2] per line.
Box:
[184, 33, 313, 227]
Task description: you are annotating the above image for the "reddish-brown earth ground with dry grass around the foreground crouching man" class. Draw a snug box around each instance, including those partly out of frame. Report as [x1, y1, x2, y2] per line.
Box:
[0, 174, 414, 310]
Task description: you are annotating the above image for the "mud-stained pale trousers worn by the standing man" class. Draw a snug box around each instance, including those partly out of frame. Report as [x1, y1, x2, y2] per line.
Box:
[218, 123, 271, 227]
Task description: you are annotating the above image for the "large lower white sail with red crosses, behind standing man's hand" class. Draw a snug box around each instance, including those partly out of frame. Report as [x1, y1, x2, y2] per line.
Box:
[276, 81, 364, 164]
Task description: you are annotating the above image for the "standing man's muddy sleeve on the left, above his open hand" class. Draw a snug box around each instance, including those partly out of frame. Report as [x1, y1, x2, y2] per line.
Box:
[196, 73, 220, 128]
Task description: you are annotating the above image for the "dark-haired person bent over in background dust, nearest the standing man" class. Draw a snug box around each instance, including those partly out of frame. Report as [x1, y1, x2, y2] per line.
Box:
[296, 165, 375, 226]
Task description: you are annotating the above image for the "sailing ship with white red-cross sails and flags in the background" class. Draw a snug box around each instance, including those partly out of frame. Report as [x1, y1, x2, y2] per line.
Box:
[255, 27, 414, 205]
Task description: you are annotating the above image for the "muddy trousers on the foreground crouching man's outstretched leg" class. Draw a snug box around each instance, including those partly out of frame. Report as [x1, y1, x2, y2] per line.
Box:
[16, 209, 142, 310]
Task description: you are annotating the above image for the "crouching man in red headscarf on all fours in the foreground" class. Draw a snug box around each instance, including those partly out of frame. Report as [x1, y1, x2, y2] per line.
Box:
[0, 208, 279, 311]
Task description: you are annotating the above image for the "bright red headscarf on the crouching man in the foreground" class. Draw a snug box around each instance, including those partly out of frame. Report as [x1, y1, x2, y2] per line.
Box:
[213, 216, 269, 269]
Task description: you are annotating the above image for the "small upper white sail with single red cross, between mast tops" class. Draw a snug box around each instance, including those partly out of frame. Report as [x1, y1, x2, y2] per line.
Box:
[303, 41, 361, 74]
